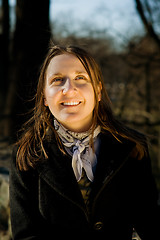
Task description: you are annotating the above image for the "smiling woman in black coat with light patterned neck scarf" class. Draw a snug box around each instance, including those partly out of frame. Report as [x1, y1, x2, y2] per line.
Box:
[10, 46, 160, 240]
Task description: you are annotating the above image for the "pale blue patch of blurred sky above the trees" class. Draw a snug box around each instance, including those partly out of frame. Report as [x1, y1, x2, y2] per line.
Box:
[50, 0, 144, 44]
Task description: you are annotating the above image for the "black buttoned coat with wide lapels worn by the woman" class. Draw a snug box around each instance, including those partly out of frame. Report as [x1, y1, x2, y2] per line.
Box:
[10, 132, 160, 240]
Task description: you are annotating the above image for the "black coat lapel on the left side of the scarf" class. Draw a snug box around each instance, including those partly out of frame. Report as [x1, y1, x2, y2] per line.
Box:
[38, 141, 84, 207]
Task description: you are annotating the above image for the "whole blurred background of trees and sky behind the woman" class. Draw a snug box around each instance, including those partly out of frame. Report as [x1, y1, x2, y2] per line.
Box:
[0, 0, 160, 240]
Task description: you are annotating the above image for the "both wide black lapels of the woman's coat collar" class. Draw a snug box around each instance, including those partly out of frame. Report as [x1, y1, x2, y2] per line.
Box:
[37, 129, 135, 208]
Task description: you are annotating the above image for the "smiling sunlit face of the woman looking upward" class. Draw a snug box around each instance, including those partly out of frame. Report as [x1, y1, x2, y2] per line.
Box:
[44, 53, 98, 132]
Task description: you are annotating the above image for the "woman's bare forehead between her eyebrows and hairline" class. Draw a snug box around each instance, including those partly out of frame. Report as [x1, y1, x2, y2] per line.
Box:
[47, 53, 86, 74]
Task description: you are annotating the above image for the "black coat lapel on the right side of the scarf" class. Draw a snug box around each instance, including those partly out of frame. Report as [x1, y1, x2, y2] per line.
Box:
[90, 132, 135, 199]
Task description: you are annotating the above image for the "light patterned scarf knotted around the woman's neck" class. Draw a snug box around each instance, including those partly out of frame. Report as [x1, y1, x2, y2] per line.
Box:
[54, 119, 101, 182]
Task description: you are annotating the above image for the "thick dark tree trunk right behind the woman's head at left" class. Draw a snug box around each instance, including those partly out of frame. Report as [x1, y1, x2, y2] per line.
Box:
[6, 0, 51, 139]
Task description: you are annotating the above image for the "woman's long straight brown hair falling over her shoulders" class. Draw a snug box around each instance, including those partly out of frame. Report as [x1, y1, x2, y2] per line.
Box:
[17, 45, 145, 170]
